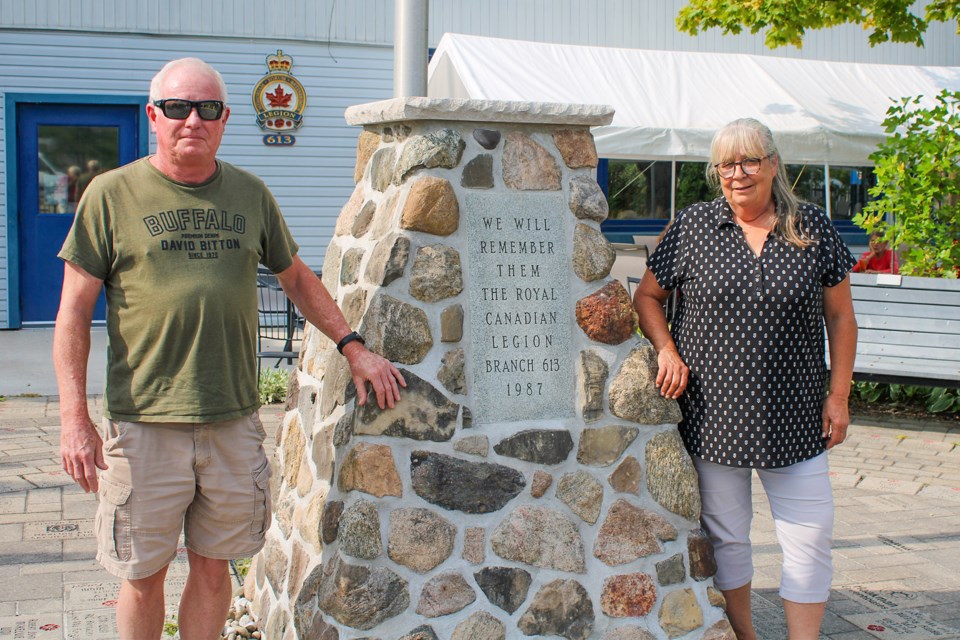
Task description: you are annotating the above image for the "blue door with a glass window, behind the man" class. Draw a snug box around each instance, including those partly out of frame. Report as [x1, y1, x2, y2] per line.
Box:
[17, 102, 142, 324]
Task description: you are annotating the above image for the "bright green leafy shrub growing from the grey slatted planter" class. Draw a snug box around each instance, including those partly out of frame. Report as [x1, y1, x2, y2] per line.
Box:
[853, 90, 960, 278]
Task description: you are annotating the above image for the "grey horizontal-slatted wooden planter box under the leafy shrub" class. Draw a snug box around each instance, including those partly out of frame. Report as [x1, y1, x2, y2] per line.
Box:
[850, 273, 960, 388]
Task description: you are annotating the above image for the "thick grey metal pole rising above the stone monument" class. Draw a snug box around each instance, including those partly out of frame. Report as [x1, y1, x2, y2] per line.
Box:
[393, 0, 429, 98]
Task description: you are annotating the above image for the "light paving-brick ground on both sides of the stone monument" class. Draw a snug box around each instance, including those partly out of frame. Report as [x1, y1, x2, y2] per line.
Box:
[0, 396, 960, 640]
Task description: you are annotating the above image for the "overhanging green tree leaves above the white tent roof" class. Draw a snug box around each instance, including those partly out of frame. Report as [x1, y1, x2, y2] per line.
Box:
[677, 0, 960, 49]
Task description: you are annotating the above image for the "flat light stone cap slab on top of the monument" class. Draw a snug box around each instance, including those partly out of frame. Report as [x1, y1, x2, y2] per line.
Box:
[344, 97, 614, 127]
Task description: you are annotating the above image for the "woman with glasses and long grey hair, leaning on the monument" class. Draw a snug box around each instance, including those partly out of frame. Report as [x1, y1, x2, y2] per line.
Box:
[634, 119, 857, 640]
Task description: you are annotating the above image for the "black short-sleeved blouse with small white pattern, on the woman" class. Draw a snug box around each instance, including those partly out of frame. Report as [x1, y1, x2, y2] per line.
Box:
[647, 196, 856, 468]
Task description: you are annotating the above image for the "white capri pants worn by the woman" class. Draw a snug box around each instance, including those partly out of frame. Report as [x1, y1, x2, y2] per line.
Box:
[693, 452, 833, 603]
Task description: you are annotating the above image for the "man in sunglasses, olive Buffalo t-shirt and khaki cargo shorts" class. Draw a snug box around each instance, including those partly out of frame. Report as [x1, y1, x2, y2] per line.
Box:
[54, 58, 405, 640]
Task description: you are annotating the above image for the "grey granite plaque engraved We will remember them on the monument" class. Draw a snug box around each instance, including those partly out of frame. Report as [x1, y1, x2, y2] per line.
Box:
[463, 192, 576, 424]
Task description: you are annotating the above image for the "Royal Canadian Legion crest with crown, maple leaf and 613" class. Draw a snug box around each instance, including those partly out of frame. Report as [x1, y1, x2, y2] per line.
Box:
[253, 49, 307, 146]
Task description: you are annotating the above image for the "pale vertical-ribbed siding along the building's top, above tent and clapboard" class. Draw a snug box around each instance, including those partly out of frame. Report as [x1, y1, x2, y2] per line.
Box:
[0, 0, 960, 66]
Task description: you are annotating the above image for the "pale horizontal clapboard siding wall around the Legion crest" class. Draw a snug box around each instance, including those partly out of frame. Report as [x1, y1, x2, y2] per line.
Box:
[0, 31, 393, 327]
